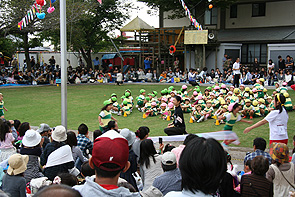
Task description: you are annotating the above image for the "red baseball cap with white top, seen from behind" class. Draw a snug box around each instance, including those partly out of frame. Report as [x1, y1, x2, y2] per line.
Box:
[92, 130, 129, 171]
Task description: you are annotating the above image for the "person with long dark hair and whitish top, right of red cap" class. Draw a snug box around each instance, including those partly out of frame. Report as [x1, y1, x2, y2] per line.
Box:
[139, 139, 164, 191]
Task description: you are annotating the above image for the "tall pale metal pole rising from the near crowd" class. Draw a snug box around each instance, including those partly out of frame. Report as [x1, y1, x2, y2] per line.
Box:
[60, 0, 68, 128]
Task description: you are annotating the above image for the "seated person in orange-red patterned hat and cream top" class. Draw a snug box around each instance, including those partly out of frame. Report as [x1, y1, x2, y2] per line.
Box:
[266, 143, 295, 196]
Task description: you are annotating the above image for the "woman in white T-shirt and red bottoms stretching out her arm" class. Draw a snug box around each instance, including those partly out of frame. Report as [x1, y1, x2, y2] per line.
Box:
[244, 94, 289, 144]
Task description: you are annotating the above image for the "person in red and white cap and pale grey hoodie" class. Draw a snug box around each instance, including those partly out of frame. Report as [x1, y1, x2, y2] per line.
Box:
[74, 130, 140, 197]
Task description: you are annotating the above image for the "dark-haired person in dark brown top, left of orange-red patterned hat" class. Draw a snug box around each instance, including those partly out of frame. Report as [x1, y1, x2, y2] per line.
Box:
[241, 155, 272, 196]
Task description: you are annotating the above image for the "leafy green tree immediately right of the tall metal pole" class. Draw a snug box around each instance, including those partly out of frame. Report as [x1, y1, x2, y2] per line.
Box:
[68, 0, 130, 68]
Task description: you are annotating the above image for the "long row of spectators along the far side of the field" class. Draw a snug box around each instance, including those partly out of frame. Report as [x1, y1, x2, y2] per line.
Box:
[0, 55, 295, 86]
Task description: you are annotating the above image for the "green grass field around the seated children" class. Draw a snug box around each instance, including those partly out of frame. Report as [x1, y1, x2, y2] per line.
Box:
[1, 84, 295, 147]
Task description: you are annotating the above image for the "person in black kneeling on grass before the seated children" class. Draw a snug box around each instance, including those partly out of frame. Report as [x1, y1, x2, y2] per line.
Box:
[164, 96, 186, 135]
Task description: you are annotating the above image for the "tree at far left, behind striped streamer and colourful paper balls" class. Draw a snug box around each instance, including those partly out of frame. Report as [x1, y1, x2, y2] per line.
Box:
[0, 0, 90, 69]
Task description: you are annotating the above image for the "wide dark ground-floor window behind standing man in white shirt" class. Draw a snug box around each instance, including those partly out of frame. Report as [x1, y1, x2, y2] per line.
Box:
[241, 44, 267, 64]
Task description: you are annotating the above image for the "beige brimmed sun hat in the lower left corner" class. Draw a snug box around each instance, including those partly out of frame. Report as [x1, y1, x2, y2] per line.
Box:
[7, 153, 29, 175]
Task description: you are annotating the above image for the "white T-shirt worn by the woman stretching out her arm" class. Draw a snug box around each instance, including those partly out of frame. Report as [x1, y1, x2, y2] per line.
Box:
[264, 109, 289, 140]
